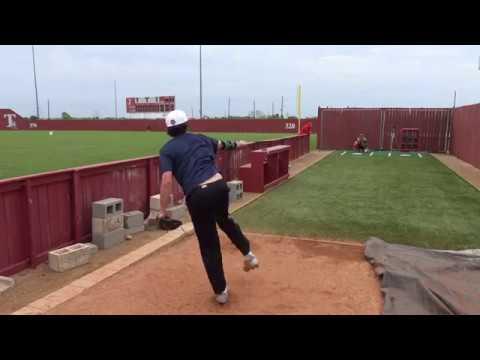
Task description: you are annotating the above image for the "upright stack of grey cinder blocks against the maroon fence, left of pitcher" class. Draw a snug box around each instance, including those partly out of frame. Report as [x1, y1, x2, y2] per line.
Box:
[92, 198, 125, 249]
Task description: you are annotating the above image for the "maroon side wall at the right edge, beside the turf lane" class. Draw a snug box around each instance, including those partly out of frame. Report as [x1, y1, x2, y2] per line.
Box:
[452, 104, 480, 168]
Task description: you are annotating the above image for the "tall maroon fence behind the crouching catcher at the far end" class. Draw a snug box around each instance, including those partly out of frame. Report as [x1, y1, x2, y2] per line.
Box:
[317, 108, 452, 152]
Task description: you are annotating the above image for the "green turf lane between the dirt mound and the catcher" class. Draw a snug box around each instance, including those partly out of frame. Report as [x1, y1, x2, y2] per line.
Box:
[235, 151, 480, 249]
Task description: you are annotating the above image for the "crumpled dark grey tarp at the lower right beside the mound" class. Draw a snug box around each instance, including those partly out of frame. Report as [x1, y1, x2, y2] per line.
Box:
[365, 238, 480, 315]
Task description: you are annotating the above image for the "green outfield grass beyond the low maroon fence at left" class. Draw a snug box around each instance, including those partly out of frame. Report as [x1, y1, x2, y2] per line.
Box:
[0, 131, 316, 179]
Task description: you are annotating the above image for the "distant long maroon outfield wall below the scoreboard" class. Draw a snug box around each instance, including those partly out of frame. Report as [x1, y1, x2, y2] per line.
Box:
[9, 118, 316, 133]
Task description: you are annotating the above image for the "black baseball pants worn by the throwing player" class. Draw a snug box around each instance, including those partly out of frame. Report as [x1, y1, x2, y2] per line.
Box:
[187, 179, 250, 294]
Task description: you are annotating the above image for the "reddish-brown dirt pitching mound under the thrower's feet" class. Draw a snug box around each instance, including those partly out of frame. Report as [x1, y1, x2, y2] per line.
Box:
[49, 234, 382, 314]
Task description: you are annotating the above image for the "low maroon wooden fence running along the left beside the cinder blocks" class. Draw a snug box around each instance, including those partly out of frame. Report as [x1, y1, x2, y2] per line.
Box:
[0, 135, 309, 275]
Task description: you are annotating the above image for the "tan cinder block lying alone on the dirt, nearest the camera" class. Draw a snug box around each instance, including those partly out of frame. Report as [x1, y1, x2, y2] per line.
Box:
[48, 243, 97, 272]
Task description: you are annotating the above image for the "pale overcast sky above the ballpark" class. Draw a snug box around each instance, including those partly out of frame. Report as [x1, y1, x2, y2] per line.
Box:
[0, 45, 480, 117]
